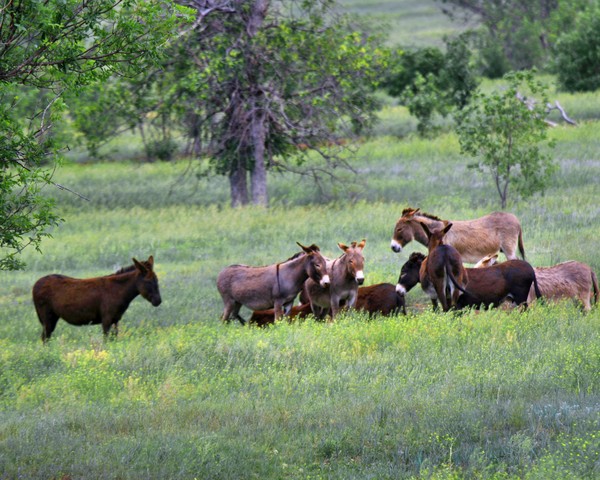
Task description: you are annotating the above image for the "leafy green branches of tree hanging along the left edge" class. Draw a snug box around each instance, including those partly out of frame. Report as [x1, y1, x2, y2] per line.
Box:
[0, 0, 183, 270]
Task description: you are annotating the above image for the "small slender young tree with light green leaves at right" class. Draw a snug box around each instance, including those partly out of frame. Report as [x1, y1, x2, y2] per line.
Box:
[457, 71, 556, 208]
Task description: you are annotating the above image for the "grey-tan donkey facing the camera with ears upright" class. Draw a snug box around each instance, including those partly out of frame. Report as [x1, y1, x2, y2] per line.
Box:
[304, 239, 367, 320]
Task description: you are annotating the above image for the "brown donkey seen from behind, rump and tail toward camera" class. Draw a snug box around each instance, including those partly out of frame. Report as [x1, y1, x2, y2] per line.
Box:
[420, 223, 467, 312]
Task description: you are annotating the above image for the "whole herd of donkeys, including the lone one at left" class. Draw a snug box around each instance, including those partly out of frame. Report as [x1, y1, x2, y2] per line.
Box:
[33, 208, 598, 341]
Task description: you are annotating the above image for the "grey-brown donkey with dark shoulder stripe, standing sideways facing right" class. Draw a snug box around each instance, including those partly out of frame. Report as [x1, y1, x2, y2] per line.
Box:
[217, 243, 329, 325]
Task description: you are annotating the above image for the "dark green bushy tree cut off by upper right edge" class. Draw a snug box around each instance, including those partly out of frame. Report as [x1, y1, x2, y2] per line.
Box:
[555, 2, 600, 92]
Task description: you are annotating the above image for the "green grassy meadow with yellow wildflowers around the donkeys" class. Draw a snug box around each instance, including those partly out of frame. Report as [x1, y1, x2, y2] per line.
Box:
[0, 0, 600, 480]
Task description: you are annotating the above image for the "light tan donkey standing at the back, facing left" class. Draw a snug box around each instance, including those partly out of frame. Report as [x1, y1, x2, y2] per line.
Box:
[390, 208, 525, 263]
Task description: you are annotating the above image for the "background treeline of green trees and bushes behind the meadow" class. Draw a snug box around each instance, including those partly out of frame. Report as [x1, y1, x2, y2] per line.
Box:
[0, 0, 600, 269]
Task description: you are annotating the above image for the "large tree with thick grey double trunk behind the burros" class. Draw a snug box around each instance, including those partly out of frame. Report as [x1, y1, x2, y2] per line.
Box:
[72, 0, 385, 206]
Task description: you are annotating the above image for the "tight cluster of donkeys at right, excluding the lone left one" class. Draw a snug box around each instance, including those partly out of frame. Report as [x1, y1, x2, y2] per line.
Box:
[217, 208, 598, 326]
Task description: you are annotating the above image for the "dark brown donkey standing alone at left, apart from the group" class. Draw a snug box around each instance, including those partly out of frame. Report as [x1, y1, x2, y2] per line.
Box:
[33, 255, 161, 342]
